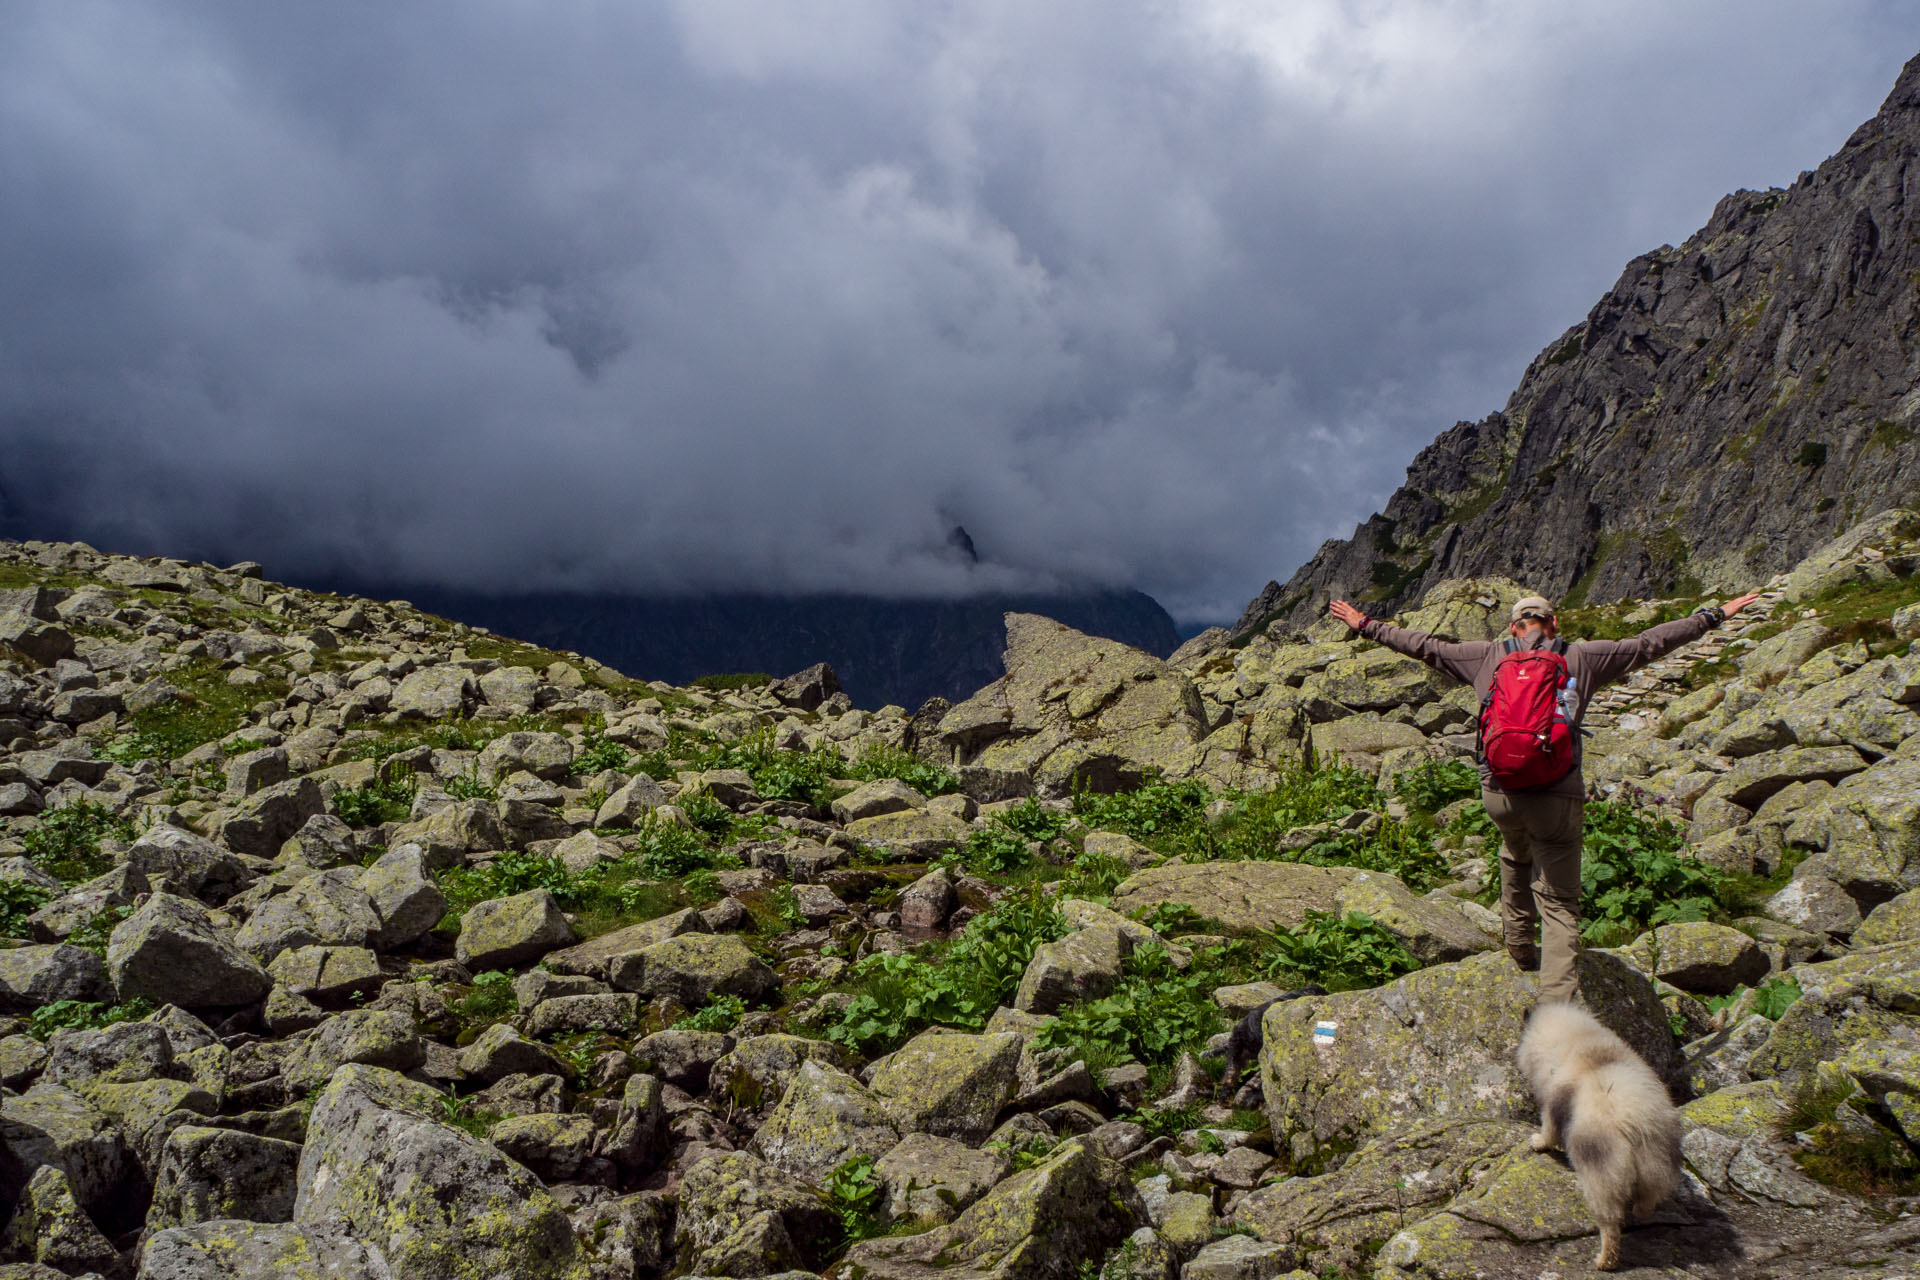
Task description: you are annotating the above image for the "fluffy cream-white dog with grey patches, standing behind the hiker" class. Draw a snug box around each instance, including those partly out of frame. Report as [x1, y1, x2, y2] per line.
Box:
[1519, 1004, 1680, 1270]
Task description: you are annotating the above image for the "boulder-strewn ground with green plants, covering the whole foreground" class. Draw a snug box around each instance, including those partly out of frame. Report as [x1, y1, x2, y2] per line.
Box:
[0, 510, 1920, 1280]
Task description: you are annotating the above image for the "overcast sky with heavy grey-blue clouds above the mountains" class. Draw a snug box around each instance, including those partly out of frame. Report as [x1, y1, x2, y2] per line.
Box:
[0, 0, 1920, 620]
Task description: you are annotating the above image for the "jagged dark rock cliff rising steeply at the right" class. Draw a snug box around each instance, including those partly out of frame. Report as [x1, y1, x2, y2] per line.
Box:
[1235, 51, 1920, 635]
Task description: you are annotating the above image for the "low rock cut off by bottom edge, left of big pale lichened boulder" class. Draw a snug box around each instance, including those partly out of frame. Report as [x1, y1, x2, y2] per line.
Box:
[136, 1221, 389, 1280]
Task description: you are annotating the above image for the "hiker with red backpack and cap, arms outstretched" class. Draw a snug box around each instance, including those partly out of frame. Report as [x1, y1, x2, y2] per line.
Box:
[1329, 591, 1759, 1002]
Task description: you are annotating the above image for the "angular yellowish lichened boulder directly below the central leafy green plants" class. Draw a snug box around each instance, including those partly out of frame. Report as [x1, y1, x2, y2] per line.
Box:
[870, 1029, 1021, 1144]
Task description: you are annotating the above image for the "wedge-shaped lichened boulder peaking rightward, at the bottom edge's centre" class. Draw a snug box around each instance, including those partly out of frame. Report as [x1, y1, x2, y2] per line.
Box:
[845, 1140, 1146, 1280]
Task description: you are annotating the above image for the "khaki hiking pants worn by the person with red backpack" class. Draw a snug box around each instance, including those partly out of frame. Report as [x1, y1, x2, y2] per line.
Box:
[1480, 791, 1586, 1004]
